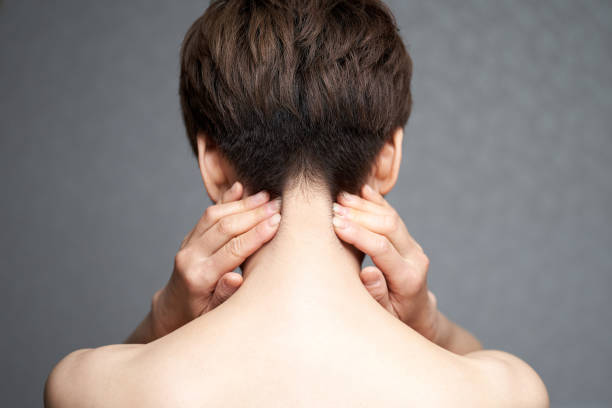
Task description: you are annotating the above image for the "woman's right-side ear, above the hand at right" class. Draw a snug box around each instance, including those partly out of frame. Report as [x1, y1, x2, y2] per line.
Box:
[368, 127, 404, 195]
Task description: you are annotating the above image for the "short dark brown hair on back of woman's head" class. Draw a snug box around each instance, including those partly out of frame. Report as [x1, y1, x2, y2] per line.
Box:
[179, 0, 412, 197]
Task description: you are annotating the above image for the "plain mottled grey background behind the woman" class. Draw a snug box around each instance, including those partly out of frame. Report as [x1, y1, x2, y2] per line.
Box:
[0, 0, 612, 407]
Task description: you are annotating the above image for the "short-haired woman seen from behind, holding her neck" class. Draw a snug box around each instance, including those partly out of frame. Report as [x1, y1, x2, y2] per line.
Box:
[45, 0, 548, 407]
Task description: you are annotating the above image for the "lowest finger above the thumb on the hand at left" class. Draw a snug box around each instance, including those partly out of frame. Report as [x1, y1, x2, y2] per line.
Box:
[209, 213, 281, 279]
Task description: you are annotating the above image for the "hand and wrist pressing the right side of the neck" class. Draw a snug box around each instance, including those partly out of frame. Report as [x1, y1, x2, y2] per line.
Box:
[334, 184, 439, 342]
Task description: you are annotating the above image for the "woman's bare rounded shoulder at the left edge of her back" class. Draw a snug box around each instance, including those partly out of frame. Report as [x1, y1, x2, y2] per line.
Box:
[44, 344, 144, 408]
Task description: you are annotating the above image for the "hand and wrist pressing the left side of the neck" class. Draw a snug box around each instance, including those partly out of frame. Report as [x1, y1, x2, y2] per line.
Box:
[149, 182, 280, 341]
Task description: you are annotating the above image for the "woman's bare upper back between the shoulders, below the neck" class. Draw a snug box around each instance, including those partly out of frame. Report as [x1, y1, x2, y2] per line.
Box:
[91, 282, 490, 407]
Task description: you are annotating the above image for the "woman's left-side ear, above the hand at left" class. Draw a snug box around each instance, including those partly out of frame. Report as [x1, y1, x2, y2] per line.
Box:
[196, 132, 236, 203]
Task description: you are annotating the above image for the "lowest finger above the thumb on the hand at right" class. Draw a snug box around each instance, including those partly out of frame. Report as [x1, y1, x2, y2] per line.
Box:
[333, 216, 422, 295]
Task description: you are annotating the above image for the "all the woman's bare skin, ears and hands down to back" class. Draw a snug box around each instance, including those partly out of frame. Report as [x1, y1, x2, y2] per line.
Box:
[45, 129, 549, 407]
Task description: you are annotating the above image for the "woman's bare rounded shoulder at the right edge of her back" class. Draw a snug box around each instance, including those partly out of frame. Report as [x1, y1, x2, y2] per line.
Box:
[464, 350, 550, 408]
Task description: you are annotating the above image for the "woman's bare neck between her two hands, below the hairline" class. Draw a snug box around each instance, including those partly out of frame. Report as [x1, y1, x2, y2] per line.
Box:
[240, 183, 365, 301]
